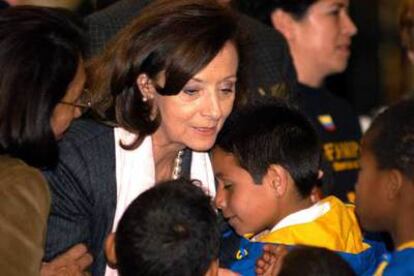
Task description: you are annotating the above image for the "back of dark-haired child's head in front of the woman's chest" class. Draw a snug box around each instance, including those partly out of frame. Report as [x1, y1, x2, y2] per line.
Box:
[115, 179, 220, 276]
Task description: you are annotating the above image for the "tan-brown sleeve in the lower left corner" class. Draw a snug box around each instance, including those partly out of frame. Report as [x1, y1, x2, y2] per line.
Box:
[0, 165, 50, 276]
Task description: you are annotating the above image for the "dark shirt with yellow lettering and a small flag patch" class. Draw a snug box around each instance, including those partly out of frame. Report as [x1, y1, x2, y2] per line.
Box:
[298, 84, 361, 201]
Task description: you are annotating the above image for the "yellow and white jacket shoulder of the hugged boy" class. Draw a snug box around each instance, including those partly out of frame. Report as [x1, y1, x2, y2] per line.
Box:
[260, 196, 368, 253]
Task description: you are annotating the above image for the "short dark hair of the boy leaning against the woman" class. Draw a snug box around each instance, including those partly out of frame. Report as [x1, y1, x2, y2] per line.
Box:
[216, 97, 320, 197]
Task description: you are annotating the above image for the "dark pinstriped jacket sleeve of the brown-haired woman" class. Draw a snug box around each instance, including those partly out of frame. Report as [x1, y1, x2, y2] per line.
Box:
[44, 139, 93, 262]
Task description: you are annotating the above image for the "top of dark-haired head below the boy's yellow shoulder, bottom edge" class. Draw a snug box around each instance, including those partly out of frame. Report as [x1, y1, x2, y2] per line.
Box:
[278, 246, 355, 276]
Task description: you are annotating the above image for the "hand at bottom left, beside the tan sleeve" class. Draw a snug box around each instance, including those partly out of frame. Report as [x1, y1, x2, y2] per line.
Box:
[40, 243, 93, 276]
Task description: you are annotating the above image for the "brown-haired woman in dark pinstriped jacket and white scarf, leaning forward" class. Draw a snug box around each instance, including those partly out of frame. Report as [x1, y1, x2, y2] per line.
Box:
[45, 0, 246, 275]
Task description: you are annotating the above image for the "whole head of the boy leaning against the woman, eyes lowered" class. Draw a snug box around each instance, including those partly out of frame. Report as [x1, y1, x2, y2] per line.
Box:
[213, 98, 320, 235]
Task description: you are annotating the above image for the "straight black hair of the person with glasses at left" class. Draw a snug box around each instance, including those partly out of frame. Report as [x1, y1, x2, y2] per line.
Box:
[0, 6, 84, 167]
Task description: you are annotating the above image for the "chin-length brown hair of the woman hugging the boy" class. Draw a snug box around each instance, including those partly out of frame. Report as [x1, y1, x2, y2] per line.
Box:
[90, 0, 242, 148]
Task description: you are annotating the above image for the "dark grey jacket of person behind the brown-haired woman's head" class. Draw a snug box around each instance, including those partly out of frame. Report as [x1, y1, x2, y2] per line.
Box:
[86, 0, 296, 99]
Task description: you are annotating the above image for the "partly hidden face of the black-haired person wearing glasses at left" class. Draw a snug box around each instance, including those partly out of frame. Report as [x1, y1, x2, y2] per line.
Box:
[50, 61, 86, 140]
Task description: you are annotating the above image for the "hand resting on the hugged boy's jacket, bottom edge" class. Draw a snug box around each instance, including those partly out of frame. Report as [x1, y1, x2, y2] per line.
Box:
[256, 244, 288, 276]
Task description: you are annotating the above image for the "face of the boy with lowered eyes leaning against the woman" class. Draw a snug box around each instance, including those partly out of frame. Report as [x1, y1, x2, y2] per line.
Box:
[213, 147, 278, 235]
